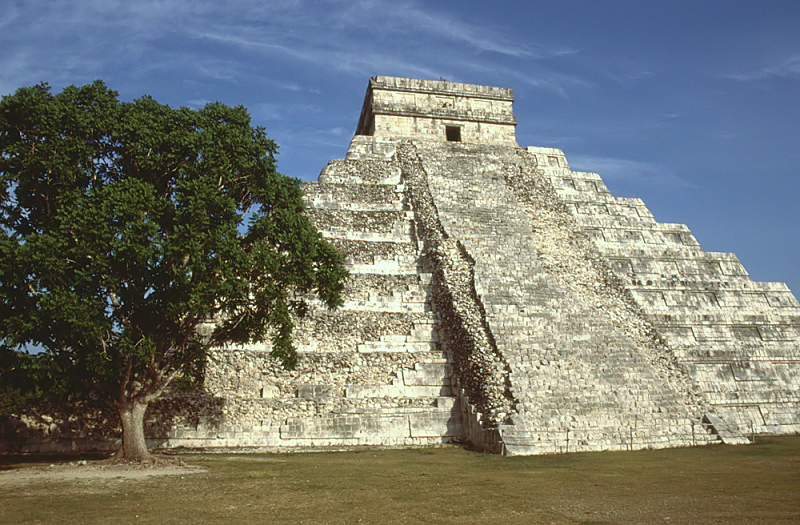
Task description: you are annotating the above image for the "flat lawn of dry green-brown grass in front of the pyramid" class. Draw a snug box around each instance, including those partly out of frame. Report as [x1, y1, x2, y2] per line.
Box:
[0, 436, 800, 524]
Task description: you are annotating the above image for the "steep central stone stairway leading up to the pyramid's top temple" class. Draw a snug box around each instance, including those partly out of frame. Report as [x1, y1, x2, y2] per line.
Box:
[406, 144, 716, 454]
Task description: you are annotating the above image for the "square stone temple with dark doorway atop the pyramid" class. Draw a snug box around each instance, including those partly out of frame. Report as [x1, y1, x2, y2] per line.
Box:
[356, 76, 517, 146]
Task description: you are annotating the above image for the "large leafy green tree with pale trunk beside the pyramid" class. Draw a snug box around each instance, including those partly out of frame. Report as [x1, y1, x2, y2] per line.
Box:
[0, 81, 347, 461]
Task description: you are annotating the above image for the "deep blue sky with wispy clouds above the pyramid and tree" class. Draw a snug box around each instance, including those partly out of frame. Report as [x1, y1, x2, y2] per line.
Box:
[0, 0, 800, 294]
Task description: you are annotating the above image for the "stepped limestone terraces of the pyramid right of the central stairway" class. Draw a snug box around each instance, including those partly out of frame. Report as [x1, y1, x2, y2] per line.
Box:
[528, 144, 800, 433]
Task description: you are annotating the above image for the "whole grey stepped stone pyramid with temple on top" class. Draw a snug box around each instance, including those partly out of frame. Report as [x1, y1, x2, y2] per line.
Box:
[156, 76, 800, 454]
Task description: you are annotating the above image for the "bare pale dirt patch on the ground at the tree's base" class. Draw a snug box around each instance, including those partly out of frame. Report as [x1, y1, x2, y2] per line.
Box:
[0, 460, 206, 486]
